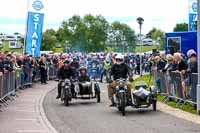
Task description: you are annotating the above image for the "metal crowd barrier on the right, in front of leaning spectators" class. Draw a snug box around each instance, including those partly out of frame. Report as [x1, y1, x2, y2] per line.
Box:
[155, 72, 198, 106]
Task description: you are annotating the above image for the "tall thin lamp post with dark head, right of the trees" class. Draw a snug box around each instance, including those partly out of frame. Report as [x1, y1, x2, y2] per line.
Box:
[137, 17, 144, 76]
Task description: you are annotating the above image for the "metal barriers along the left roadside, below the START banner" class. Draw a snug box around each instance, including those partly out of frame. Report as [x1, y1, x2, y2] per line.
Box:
[0, 66, 57, 111]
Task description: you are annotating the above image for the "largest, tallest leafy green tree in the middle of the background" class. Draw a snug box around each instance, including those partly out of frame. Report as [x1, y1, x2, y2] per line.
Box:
[57, 14, 109, 52]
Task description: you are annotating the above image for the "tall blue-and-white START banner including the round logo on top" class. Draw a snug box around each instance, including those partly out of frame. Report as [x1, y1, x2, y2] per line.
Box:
[24, 0, 44, 57]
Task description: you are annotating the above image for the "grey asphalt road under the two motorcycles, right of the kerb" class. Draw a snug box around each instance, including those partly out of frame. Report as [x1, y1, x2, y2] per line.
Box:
[43, 84, 200, 133]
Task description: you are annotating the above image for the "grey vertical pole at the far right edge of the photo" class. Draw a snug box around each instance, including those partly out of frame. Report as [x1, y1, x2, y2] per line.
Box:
[197, 0, 200, 115]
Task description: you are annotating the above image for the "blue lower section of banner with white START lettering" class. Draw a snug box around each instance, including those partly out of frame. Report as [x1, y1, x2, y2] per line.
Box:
[24, 12, 44, 57]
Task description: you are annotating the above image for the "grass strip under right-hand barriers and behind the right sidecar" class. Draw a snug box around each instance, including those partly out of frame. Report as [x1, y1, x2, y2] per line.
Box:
[132, 75, 197, 114]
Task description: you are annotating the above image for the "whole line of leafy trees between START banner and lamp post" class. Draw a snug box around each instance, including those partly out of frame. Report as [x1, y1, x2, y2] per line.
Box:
[41, 14, 137, 52]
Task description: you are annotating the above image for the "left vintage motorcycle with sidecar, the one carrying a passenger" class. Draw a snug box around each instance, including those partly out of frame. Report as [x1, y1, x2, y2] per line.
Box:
[61, 79, 101, 106]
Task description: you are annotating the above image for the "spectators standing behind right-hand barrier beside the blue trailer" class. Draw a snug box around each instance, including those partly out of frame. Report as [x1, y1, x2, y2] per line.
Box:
[149, 49, 198, 104]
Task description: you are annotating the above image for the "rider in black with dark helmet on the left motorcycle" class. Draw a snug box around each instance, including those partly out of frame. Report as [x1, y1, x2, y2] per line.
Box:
[56, 60, 73, 99]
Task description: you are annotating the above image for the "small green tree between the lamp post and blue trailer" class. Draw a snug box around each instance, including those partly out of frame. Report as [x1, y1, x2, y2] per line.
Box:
[146, 27, 165, 50]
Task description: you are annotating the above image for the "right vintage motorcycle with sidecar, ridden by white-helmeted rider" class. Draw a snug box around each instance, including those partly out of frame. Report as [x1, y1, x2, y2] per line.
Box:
[112, 79, 157, 116]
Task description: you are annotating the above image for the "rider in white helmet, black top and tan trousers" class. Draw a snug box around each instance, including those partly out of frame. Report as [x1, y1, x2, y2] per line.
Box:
[108, 54, 133, 107]
